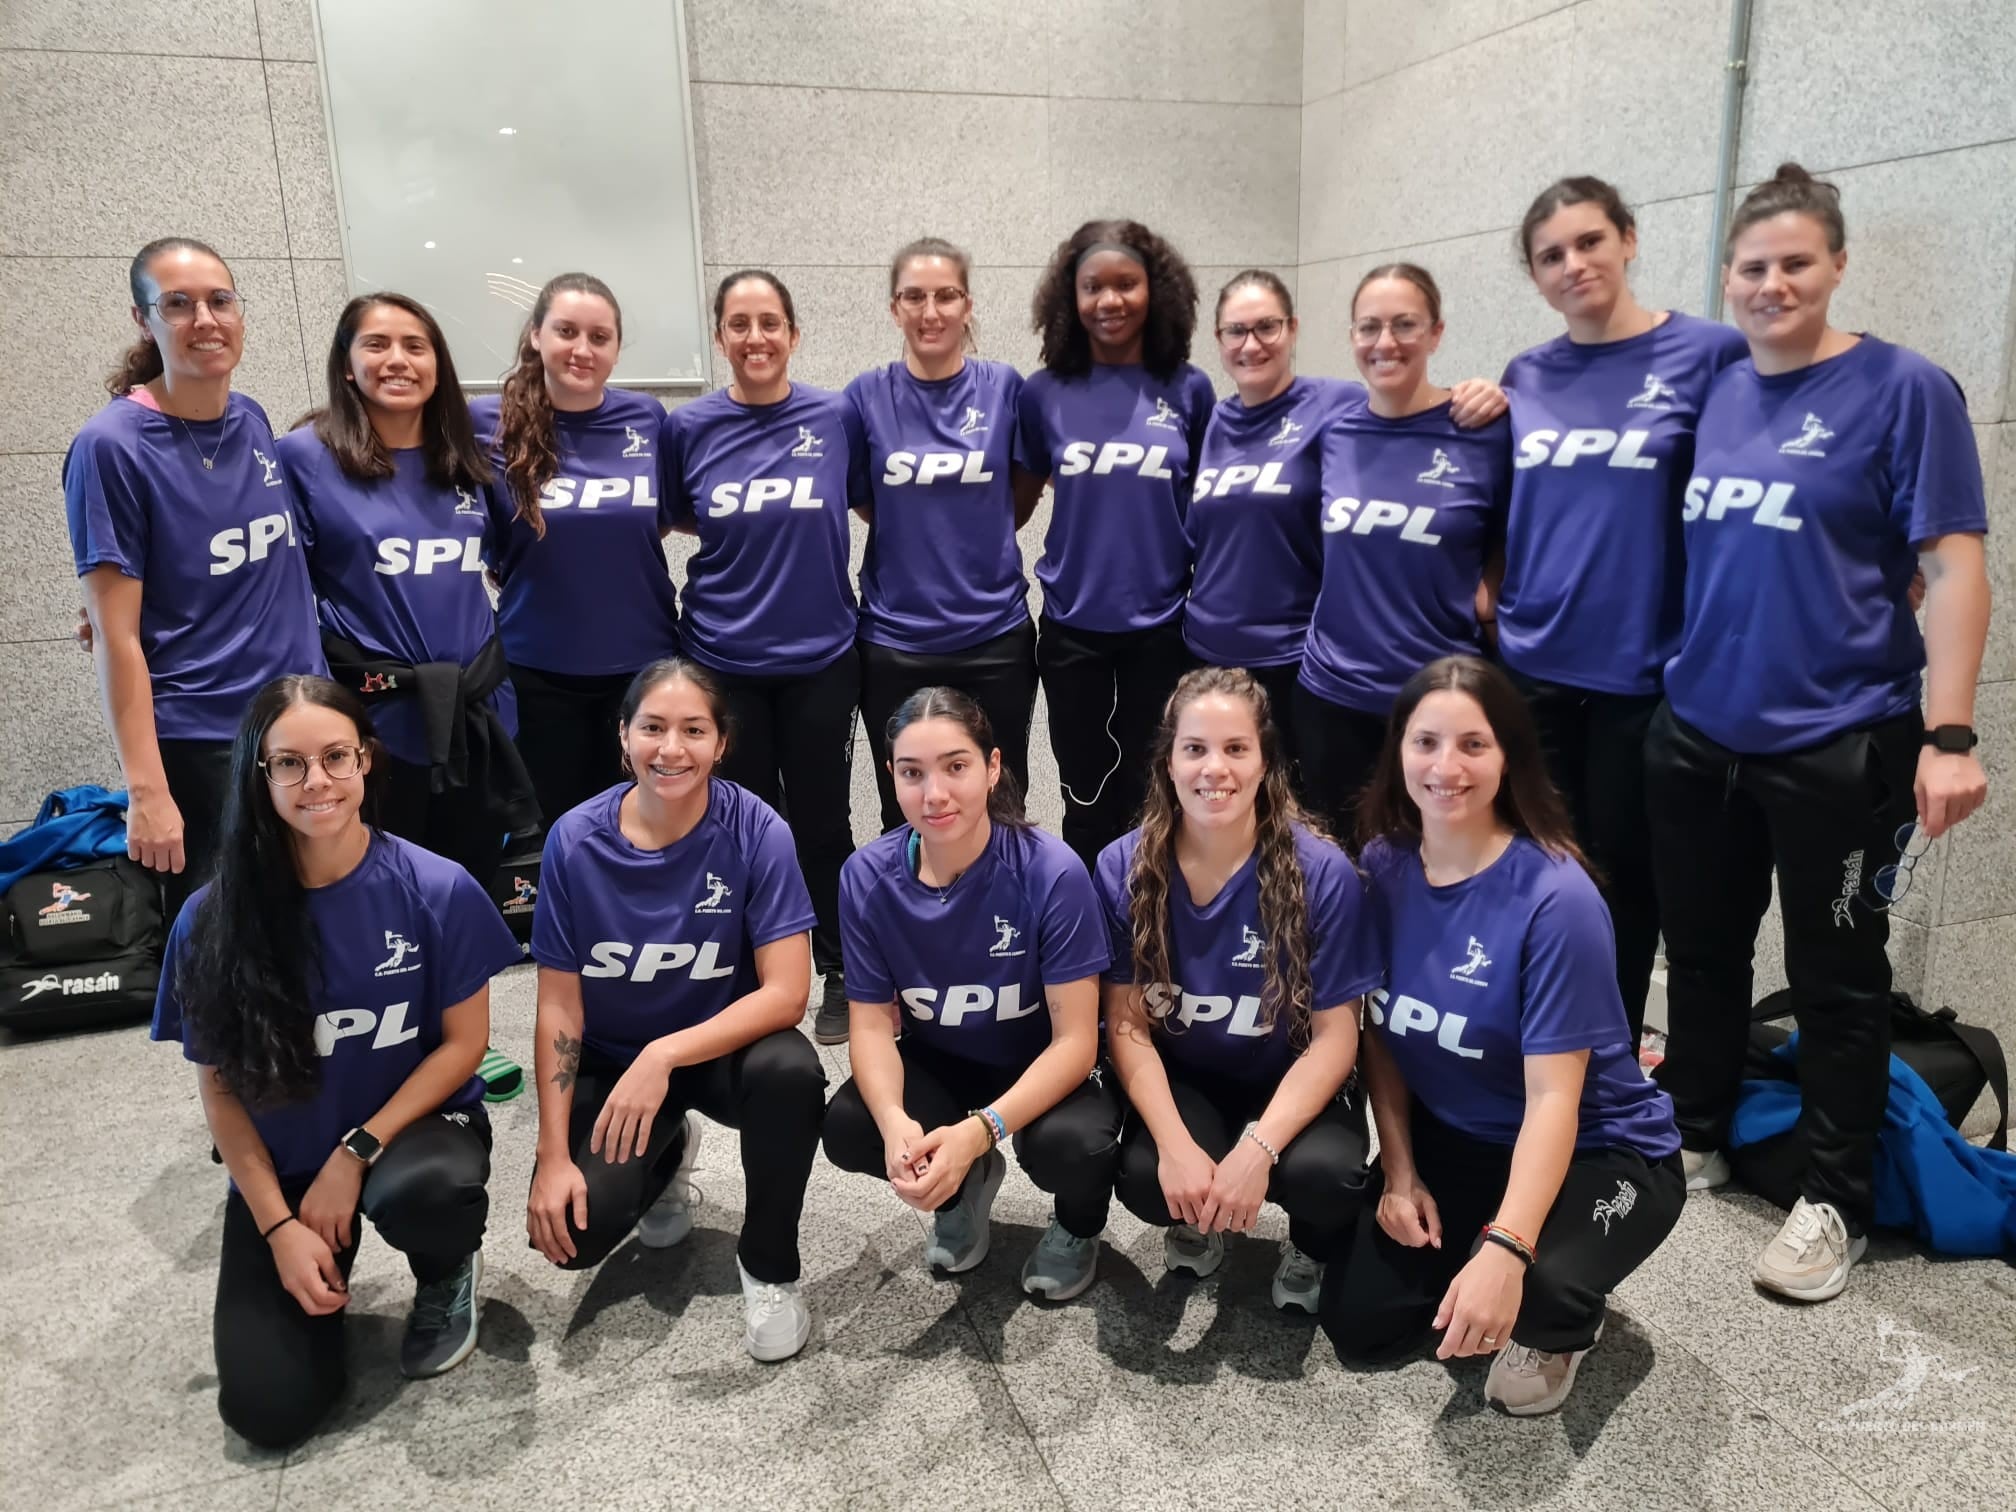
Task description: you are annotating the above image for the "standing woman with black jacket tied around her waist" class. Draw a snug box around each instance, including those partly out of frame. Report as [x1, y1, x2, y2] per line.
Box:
[278, 292, 538, 887]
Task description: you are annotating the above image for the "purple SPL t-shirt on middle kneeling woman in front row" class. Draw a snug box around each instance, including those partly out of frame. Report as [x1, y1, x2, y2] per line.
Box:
[841, 825, 1109, 1068]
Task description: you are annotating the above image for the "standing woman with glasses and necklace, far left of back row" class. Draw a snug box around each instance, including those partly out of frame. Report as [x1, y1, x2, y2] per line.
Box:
[62, 236, 323, 919]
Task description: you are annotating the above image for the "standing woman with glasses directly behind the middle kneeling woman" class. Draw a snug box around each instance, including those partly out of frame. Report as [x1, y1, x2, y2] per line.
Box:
[839, 236, 1042, 842]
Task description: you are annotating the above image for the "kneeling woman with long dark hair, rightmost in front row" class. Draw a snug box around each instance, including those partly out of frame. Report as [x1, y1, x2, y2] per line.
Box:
[1320, 657, 1685, 1417]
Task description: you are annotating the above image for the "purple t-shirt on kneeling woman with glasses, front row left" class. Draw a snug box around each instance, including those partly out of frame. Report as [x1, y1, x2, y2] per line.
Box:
[151, 831, 518, 1185]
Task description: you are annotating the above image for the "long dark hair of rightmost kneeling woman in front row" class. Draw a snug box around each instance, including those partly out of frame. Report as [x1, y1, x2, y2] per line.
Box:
[1359, 657, 1595, 875]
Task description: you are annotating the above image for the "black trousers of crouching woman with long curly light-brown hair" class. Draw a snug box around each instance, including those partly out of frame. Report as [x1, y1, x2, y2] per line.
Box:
[1115, 1060, 1371, 1262]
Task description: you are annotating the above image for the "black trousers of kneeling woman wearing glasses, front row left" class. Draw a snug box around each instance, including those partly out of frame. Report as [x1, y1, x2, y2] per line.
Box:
[212, 1109, 490, 1450]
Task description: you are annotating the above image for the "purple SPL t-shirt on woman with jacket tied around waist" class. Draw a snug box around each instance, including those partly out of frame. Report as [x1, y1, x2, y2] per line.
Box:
[278, 425, 518, 766]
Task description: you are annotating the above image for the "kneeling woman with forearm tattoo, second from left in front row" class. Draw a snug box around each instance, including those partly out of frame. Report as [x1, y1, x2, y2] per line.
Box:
[526, 657, 827, 1361]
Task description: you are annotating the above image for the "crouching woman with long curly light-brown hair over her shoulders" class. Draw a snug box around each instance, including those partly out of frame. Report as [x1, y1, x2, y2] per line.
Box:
[1095, 667, 1381, 1312]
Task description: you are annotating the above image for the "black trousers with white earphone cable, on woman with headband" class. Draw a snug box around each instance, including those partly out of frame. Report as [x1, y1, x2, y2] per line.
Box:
[1036, 617, 1195, 869]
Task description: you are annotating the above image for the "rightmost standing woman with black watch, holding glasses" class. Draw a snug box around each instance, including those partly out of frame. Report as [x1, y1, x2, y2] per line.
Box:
[1645, 163, 1990, 1302]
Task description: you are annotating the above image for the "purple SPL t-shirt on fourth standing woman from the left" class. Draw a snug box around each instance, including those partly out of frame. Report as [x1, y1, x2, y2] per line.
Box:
[665, 383, 863, 677]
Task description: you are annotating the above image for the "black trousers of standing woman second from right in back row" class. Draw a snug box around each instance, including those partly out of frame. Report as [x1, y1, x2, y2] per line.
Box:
[1506, 667, 1659, 1052]
